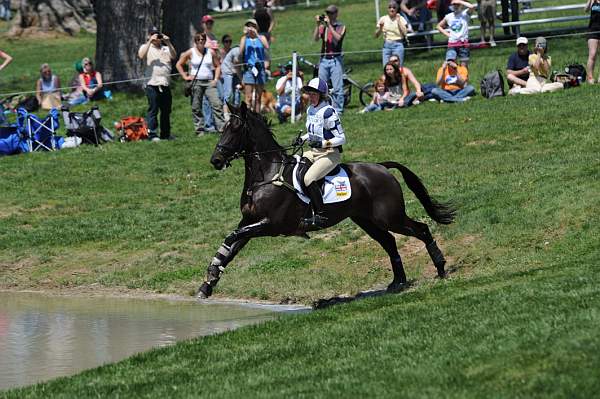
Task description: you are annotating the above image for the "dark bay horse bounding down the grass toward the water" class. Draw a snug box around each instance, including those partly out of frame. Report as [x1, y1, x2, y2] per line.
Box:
[198, 103, 455, 298]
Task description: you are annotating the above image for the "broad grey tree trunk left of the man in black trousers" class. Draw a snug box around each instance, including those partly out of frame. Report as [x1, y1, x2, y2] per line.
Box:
[95, 0, 161, 91]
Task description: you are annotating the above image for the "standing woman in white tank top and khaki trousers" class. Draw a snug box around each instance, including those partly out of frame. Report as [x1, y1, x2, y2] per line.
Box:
[175, 33, 225, 137]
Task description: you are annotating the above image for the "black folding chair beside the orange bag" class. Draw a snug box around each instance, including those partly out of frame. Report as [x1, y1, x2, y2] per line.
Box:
[61, 106, 104, 145]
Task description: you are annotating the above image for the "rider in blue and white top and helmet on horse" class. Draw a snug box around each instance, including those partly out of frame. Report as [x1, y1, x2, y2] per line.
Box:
[299, 78, 346, 228]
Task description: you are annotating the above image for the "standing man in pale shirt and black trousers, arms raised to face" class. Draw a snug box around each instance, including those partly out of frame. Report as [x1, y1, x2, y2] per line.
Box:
[138, 27, 177, 141]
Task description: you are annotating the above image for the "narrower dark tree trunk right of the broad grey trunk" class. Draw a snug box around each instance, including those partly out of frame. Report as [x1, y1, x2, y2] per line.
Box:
[163, 0, 207, 54]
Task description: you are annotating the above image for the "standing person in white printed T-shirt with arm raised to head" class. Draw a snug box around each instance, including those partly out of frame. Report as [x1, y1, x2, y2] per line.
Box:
[437, 0, 475, 67]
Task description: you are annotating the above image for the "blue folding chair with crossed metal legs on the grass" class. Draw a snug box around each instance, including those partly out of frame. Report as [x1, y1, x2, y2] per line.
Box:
[17, 108, 60, 152]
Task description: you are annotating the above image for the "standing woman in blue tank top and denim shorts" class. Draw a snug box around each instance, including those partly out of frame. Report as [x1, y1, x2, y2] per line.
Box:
[240, 18, 269, 112]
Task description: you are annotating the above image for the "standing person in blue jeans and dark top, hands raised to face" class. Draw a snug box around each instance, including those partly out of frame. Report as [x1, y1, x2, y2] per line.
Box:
[313, 4, 346, 115]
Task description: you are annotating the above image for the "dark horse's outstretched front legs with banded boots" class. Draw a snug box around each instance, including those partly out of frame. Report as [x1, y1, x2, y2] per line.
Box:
[196, 219, 268, 299]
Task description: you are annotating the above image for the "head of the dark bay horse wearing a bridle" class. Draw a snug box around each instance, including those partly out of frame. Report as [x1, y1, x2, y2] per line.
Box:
[210, 102, 248, 170]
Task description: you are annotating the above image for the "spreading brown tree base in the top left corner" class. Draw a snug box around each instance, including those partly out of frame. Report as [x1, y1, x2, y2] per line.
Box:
[8, 0, 96, 36]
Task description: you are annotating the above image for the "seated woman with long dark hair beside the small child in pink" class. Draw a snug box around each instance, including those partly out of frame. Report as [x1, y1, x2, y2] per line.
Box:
[381, 62, 423, 108]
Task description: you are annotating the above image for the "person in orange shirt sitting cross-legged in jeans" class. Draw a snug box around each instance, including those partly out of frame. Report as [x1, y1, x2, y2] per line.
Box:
[431, 50, 475, 103]
